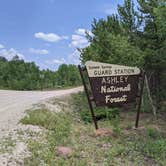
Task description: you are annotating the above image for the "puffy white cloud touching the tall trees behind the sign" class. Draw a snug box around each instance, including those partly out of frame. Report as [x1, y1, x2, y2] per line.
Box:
[69, 28, 93, 48]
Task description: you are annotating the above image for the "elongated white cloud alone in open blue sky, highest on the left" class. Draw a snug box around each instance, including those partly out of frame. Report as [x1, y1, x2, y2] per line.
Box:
[34, 32, 68, 42]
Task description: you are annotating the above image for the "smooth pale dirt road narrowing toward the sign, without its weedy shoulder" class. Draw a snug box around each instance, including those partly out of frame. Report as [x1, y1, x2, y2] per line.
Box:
[0, 87, 82, 137]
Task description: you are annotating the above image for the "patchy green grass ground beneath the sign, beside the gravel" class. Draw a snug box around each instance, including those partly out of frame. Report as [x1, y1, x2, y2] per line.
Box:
[21, 94, 166, 166]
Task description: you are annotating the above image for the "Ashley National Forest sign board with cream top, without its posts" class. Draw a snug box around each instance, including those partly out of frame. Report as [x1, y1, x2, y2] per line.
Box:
[85, 61, 141, 107]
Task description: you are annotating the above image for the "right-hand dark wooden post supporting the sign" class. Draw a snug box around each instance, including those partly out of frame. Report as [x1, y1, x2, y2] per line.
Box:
[135, 71, 145, 128]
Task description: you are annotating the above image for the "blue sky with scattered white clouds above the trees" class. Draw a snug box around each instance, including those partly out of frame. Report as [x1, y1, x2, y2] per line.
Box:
[0, 0, 123, 70]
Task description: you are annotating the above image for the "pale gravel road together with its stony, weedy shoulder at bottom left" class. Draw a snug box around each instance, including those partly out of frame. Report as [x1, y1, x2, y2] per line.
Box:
[0, 87, 83, 166]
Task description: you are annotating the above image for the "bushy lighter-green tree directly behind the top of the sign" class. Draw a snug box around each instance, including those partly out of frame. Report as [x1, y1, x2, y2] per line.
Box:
[81, 15, 144, 66]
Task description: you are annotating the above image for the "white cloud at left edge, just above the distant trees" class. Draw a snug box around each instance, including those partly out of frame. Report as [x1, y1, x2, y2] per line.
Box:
[0, 48, 25, 60]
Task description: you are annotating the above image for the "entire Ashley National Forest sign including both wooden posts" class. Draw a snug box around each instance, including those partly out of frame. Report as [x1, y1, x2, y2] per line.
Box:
[78, 61, 145, 129]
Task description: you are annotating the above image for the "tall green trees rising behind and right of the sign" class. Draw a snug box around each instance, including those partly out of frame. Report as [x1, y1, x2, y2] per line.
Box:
[80, 0, 166, 108]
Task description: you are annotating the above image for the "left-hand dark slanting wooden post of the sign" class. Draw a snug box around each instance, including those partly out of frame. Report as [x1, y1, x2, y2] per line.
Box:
[78, 65, 98, 130]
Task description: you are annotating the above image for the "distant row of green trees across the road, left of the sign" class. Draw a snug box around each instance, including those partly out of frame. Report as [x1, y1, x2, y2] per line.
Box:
[0, 55, 81, 90]
